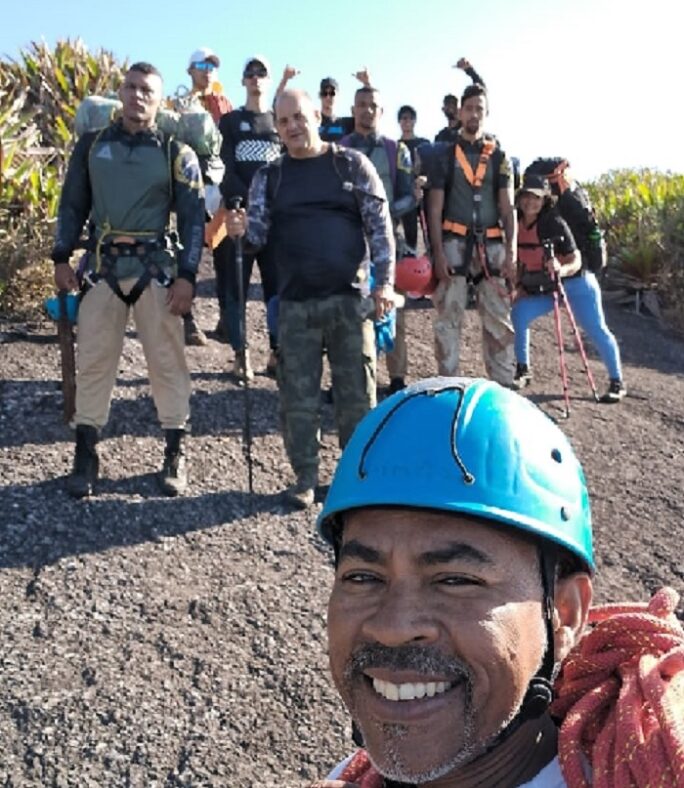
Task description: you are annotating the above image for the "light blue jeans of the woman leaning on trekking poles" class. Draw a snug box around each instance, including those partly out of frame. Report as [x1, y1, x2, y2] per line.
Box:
[511, 271, 622, 380]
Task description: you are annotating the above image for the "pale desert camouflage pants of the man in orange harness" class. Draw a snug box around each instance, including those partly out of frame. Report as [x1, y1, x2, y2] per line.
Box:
[432, 238, 514, 386]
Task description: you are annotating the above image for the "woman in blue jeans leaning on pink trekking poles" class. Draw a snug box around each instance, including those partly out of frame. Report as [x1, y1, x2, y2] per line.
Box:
[511, 174, 627, 403]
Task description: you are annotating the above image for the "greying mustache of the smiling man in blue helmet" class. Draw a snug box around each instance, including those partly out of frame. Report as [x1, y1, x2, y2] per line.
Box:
[344, 643, 472, 683]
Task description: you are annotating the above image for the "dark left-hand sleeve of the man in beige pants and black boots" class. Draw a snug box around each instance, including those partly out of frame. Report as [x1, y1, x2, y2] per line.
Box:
[50, 133, 96, 264]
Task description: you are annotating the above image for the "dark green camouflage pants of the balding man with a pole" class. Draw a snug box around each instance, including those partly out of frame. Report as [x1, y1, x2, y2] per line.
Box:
[277, 294, 376, 485]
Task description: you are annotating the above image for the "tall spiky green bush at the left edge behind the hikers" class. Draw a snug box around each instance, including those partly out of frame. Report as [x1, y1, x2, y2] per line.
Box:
[0, 40, 125, 314]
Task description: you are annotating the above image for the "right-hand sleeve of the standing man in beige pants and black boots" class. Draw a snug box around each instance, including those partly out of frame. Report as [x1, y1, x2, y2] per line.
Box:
[171, 142, 204, 284]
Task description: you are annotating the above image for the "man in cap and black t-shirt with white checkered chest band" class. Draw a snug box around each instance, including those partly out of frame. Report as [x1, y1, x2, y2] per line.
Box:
[219, 55, 282, 378]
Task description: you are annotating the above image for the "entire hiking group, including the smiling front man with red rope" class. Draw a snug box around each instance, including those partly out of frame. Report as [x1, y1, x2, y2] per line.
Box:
[52, 49, 684, 788]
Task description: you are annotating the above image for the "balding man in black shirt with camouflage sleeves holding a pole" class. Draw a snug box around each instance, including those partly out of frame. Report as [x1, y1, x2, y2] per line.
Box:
[226, 90, 395, 508]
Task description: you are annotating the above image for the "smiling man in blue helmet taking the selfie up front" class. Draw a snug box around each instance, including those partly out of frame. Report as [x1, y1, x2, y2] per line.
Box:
[319, 378, 593, 788]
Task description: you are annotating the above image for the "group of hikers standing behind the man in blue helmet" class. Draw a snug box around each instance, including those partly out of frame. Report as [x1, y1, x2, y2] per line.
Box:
[53, 48, 625, 508]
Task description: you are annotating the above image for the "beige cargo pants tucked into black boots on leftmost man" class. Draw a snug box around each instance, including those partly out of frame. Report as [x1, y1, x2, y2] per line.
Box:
[73, 278, 190, 430]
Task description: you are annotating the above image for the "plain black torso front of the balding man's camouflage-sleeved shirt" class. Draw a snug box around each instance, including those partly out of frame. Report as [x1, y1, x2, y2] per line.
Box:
[269, 150, 366, 301]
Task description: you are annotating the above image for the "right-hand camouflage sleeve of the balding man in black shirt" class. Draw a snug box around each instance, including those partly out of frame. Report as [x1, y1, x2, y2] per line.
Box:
[347, 149, 395, 287]
